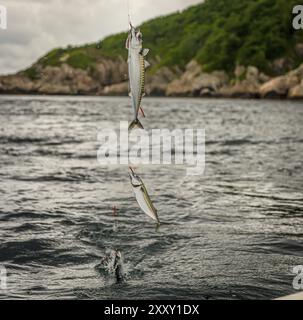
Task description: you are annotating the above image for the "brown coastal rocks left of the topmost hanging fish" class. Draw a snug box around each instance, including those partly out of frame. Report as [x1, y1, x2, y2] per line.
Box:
[0, 58, 127, 95]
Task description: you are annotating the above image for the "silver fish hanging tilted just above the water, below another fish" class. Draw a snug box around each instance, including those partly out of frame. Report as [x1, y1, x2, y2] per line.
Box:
[129, 167, 160, 225]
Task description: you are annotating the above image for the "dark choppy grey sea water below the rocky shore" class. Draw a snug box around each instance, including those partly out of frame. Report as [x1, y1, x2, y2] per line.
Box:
[0, 96, 303, 299]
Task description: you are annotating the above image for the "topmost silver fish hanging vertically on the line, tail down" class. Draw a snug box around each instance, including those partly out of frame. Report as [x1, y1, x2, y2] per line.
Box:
[126, 24, 149, 130]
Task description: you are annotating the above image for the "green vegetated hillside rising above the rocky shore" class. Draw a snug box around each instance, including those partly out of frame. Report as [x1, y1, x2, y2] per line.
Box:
[27, 0, 303, 77]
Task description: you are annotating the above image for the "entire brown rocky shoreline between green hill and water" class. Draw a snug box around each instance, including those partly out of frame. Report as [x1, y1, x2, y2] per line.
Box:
[0, 58, 303, 99]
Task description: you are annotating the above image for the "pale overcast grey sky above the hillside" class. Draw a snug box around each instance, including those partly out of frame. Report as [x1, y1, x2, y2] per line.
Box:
[0, 0, 202, 74]
